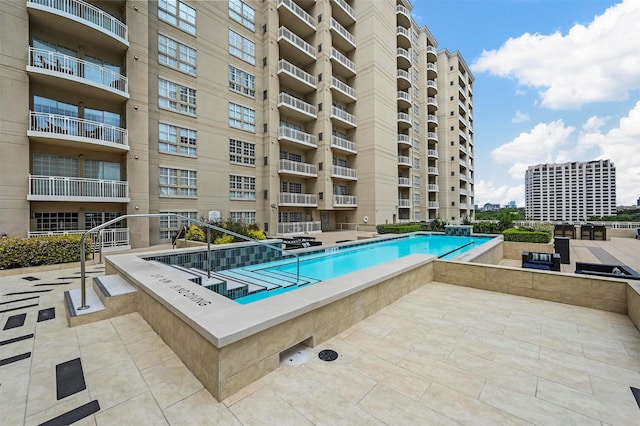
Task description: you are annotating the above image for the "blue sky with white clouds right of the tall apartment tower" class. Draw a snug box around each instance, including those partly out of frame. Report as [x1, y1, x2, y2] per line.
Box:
[412, 0, 640, 207]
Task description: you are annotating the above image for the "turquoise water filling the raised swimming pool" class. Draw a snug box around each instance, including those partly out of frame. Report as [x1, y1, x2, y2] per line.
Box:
[235, 234, 491, 304]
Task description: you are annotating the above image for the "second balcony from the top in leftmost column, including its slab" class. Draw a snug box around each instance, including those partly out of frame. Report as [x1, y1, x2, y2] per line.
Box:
[27, 47, 129, 100]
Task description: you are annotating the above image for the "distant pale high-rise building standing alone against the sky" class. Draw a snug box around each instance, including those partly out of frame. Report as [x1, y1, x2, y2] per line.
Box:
[525, 160, 616, 222]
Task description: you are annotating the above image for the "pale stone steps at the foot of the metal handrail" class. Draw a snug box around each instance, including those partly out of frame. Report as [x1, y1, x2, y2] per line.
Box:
[64, 275, 136, 327]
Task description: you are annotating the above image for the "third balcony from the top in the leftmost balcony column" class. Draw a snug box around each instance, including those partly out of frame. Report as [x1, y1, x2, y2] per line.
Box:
[27, 111, 129, 151]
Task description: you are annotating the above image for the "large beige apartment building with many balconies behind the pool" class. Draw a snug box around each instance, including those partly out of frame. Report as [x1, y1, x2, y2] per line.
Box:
[0, 0, 473, 246]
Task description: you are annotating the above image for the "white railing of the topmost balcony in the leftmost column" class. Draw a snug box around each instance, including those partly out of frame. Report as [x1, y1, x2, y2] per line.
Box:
[27, 0, 129, 46]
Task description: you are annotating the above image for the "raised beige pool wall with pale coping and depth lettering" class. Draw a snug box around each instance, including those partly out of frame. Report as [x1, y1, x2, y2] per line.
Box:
[106, 249, 436, 400]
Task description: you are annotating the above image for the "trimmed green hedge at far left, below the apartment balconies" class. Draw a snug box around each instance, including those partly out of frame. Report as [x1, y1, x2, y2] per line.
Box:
[0, 235, 91, 269]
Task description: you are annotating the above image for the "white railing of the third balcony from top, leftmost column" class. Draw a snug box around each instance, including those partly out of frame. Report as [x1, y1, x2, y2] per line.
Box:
[29, 111, 129, 149]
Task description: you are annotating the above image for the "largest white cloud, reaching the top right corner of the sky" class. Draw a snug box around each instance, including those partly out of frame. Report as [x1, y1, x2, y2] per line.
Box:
[471, 0, 640, 109]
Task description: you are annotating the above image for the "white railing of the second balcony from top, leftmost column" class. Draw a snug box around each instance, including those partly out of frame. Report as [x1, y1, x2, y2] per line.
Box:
[29, 47, 129, 98]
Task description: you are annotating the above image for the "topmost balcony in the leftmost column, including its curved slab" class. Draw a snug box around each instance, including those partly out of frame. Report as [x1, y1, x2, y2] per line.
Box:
[27, 0, 129, 52]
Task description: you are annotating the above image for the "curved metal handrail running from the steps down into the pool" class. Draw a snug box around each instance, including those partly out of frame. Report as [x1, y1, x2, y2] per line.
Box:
[77, 213, 300, 310]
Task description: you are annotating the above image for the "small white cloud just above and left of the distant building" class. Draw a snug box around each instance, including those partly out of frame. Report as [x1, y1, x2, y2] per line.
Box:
[491, 120, 575, 179]
